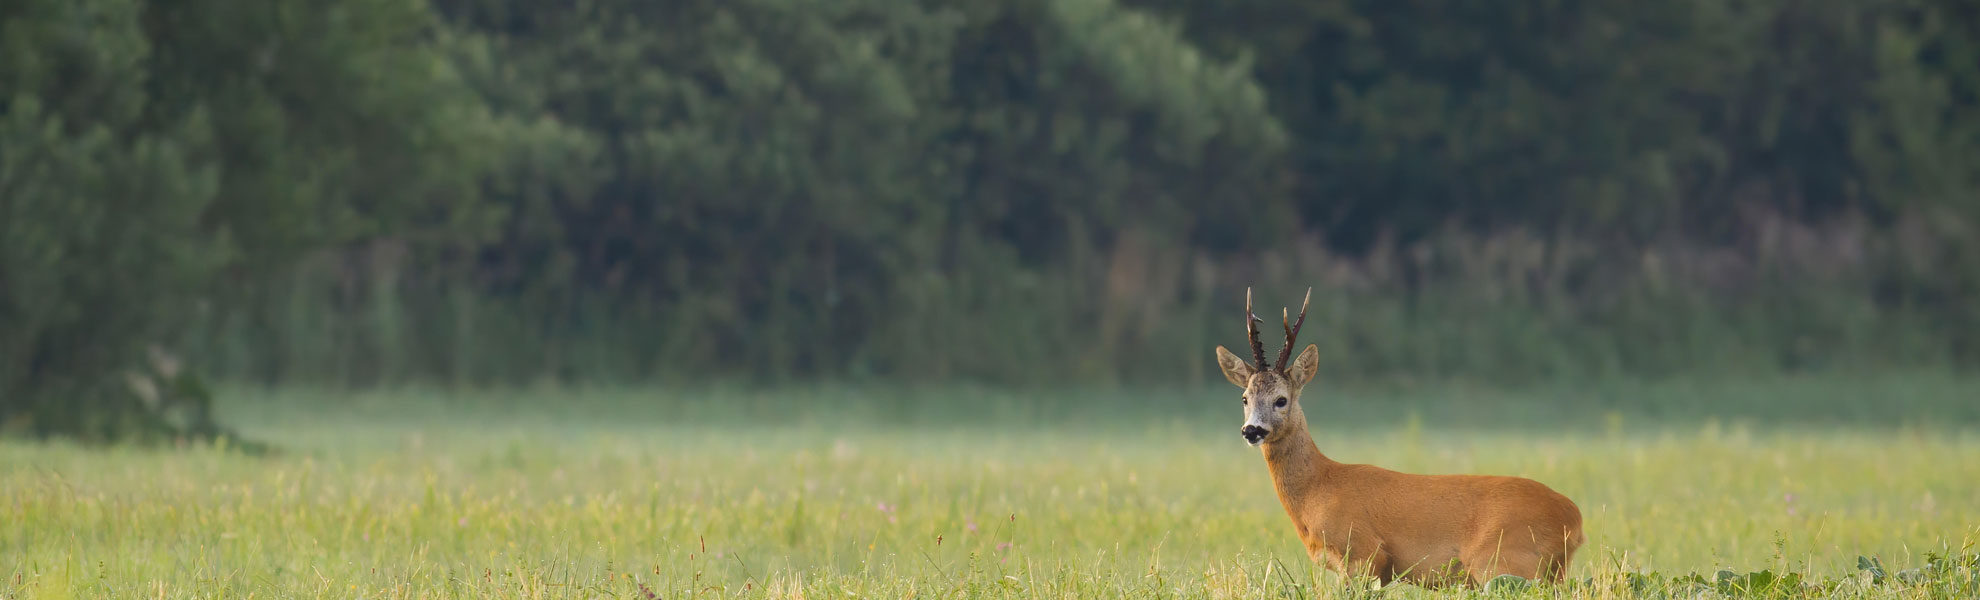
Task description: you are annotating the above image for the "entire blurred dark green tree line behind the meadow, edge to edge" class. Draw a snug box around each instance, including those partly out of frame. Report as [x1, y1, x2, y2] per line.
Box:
[0, 0, 1980, 438]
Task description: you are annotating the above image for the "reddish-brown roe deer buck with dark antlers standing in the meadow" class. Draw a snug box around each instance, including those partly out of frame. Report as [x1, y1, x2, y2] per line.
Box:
[1216, 287, 1588, 588]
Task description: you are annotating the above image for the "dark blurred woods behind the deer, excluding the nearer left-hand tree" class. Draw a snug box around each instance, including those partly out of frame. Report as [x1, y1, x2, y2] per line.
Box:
[189, 0, 1980, 396]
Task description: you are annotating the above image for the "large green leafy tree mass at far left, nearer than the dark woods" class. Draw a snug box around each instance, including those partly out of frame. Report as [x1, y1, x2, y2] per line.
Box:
[0, 0, 489, 438]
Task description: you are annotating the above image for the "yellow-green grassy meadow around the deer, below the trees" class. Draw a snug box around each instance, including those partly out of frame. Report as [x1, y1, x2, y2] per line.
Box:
[0, 376, 1980, 598]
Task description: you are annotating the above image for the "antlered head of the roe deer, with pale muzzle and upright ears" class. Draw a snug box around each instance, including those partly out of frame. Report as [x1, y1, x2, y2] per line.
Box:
[1218, 287, 1321, 446]
